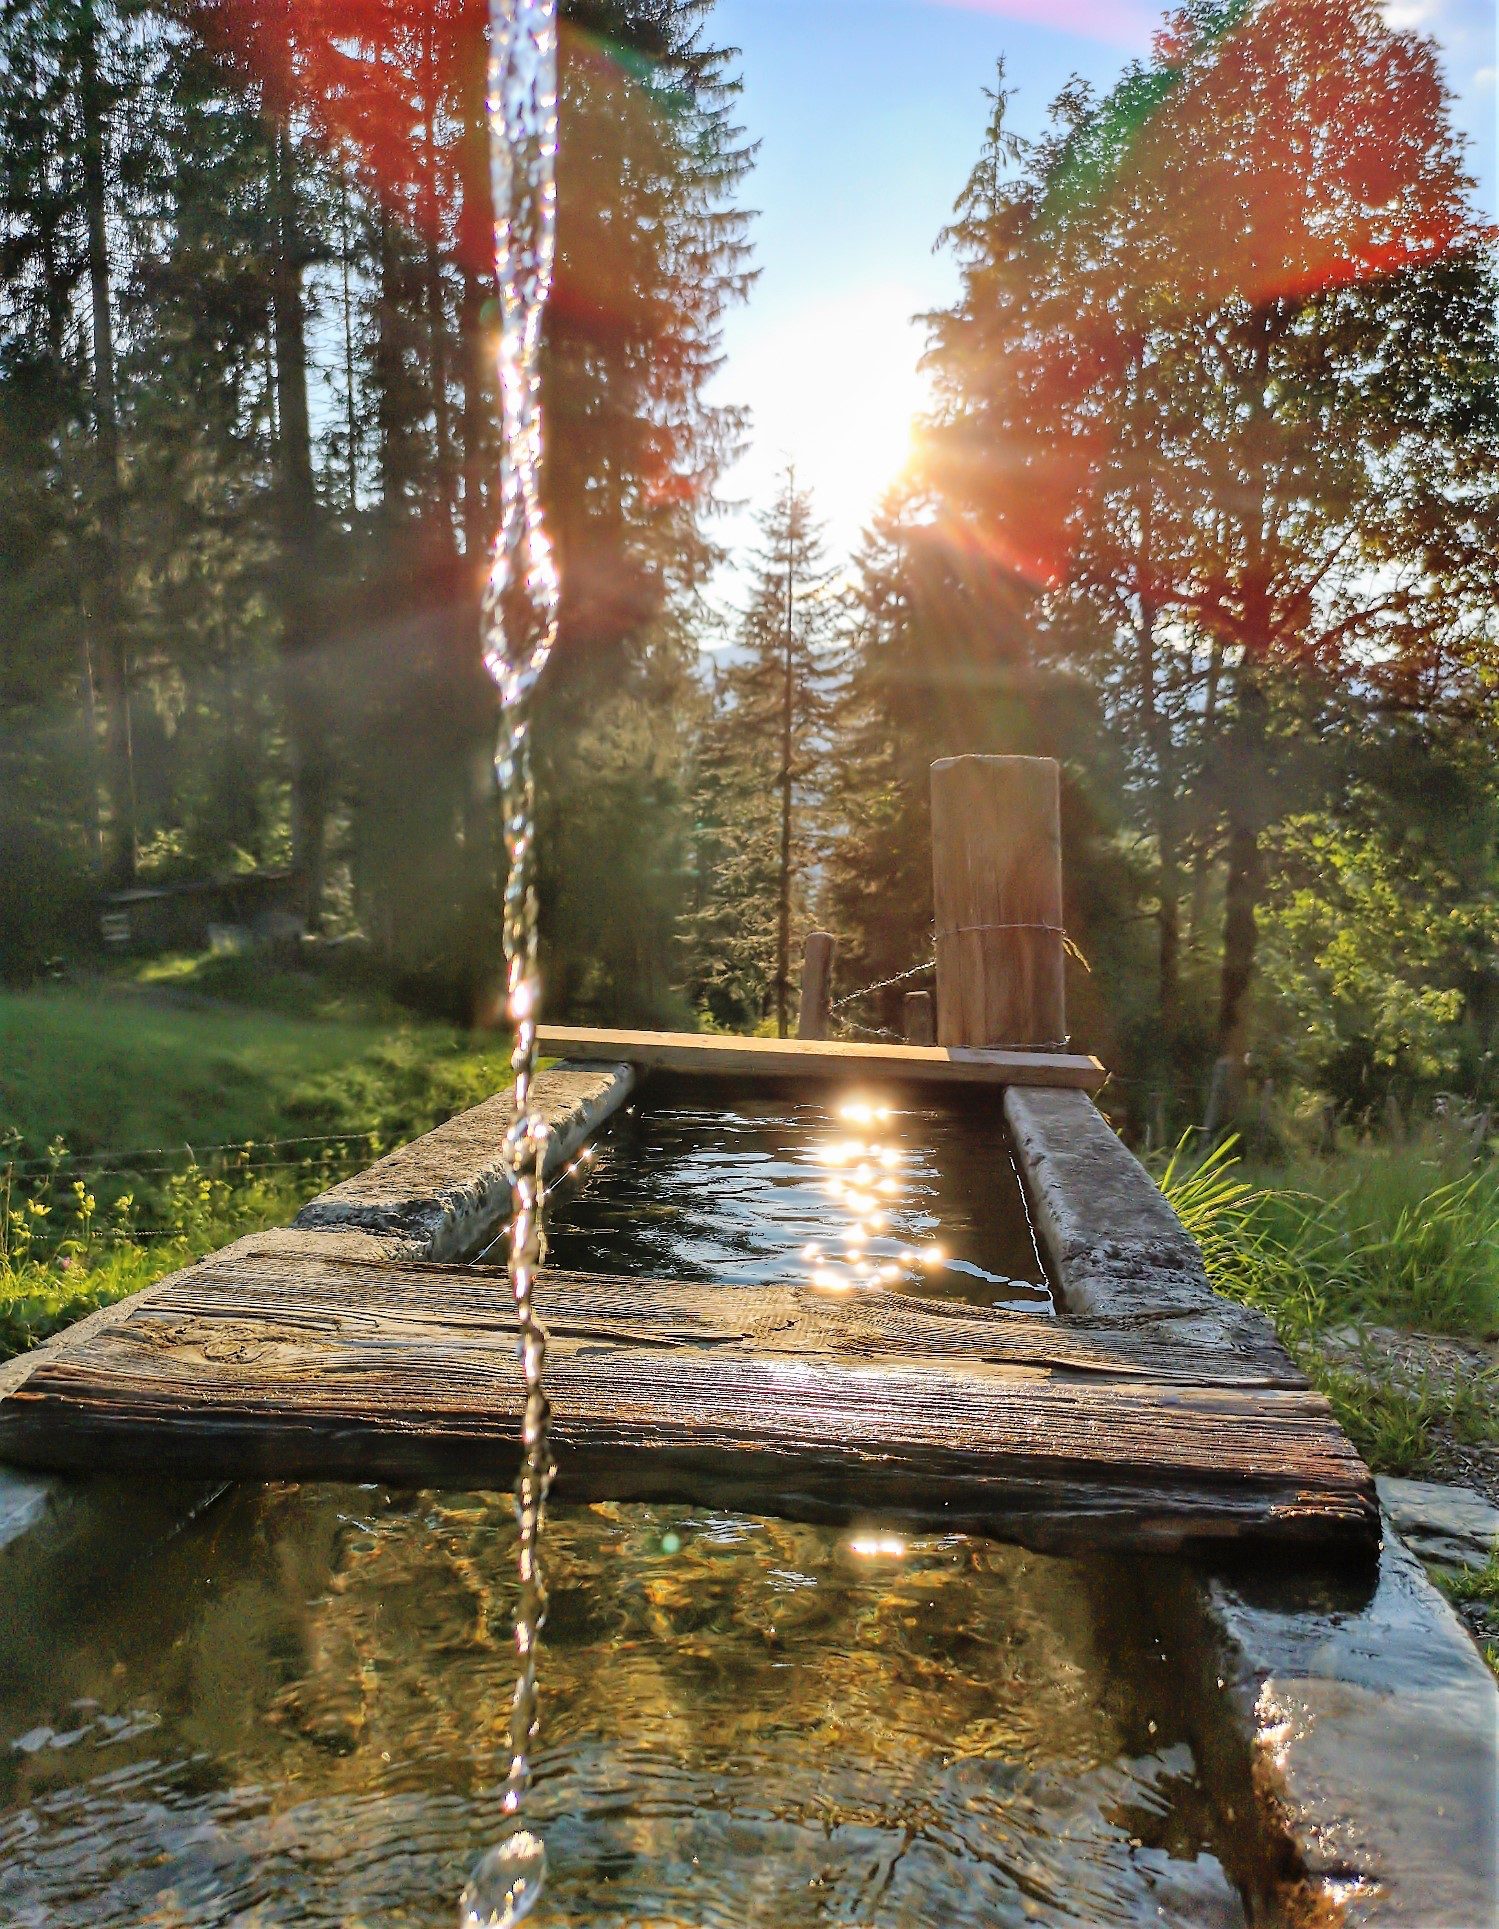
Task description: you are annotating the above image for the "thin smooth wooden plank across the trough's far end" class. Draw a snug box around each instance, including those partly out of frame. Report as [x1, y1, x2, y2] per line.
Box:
[538, 1024, 1107, 1092]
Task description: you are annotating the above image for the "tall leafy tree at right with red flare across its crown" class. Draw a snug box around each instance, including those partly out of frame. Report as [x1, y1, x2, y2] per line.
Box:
[910, 0, 1499, 1111]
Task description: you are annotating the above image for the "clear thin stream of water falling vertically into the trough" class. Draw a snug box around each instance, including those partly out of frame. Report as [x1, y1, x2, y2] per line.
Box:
[459, 0, 559, 1929]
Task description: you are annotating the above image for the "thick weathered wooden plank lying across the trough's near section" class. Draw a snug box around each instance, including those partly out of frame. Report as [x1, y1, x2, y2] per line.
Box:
[0, 1256, 1377, 1551]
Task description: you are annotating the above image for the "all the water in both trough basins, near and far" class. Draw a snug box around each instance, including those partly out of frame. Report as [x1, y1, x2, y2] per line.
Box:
[0, 1088, 1260, 1929]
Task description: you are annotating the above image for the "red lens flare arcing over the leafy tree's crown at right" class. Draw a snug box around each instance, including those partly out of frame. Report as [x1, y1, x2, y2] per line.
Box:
[928, 0, 1491, 586]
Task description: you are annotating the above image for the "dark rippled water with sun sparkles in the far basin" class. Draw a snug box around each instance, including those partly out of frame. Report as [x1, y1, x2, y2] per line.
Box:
[524, 1078, 1051, 1314]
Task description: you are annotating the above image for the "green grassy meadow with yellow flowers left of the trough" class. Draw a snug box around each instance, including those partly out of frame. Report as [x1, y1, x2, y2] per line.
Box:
[0, 961, 511, 1358]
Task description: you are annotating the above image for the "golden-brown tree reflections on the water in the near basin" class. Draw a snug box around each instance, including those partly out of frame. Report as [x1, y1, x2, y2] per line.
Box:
[0, 1470, 1237, 1925]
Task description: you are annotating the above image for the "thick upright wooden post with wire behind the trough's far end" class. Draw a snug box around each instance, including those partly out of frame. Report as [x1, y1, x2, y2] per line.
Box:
[932, 756, 1067, 1049]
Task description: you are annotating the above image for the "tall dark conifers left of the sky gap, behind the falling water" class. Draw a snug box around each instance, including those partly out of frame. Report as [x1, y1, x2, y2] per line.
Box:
[0, 0, 749, 1022]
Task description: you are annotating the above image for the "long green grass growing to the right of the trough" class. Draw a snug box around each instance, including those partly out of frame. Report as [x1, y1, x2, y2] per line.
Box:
[1161, 1127, 1499, 1474]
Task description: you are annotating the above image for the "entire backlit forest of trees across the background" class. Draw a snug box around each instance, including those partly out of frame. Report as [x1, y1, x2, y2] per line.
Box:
[0, 0, 1499, 1144]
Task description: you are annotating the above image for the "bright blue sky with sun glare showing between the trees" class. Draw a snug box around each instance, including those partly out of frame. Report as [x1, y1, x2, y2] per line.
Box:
[708, 0, 1497, 604]
